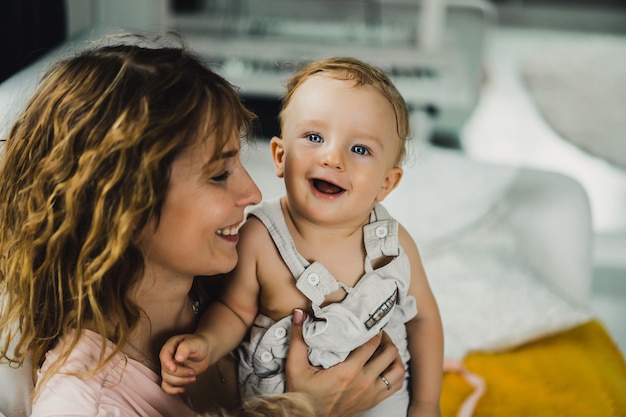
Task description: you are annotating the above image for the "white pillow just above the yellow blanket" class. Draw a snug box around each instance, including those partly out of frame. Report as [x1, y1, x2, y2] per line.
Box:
[418, 200, 592, 359]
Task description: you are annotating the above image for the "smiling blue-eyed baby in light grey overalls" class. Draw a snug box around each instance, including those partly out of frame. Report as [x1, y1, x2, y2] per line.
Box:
[161, 57, 443, 417]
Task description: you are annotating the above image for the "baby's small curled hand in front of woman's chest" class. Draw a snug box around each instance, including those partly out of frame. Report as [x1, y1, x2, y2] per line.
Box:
[159, 334, 210, 395]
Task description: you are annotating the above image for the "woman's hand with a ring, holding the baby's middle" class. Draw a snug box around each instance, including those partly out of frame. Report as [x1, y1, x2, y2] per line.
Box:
[286, 310, 404, 417]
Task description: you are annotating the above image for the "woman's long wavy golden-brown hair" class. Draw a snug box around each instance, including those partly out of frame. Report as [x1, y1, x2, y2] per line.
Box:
[0, 35, 254, 390]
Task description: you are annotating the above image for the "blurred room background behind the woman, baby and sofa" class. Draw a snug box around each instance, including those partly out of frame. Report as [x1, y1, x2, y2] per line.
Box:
[0, 0, 626, 351]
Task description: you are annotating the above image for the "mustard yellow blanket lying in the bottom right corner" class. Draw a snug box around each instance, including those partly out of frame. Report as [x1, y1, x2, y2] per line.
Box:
[441, 320, 626, 417]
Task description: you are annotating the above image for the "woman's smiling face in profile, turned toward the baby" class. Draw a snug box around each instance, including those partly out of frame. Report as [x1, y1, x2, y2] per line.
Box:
[140, 135, 261, 282]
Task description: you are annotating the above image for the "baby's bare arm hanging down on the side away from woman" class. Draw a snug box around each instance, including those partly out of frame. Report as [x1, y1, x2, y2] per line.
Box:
[400, 227, 443, 417]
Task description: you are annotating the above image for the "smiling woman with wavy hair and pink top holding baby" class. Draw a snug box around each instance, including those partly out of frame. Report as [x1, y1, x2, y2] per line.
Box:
[0, 35, 403, 416]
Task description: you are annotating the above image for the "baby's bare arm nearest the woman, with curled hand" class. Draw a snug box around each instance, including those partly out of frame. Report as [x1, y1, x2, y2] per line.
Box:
[159, 222, 260, 394]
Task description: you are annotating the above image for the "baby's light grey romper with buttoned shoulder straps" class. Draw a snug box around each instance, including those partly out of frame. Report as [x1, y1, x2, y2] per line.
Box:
[238, 200, 417, 416]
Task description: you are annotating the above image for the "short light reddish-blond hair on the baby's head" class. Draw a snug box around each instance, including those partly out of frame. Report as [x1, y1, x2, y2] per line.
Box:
[279, 57, 411, 166]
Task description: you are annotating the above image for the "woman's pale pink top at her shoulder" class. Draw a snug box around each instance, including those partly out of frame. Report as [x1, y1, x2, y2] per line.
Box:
[31, 330, 197, 417]
